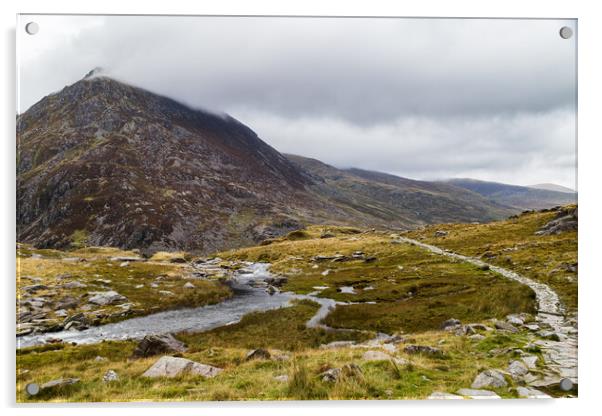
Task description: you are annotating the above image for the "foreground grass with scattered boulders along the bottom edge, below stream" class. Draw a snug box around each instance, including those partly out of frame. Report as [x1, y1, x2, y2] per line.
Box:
[17, 312, 540, 402]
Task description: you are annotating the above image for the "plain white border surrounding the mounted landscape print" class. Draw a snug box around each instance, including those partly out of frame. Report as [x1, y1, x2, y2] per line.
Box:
[0, 0, 602, 416]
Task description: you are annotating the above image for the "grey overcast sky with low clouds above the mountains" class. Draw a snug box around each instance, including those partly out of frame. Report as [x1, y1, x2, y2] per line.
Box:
[17, 16, 576, 188]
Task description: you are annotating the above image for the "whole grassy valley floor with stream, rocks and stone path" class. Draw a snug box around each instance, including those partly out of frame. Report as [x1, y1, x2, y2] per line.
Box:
[17, 206, 578, 402]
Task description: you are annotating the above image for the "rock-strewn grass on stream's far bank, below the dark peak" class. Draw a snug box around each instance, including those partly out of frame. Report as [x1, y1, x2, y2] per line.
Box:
[17, 244, 231, 324]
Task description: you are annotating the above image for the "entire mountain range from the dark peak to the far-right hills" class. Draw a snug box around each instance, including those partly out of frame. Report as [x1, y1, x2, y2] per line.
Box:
[17, 75, 570, 253]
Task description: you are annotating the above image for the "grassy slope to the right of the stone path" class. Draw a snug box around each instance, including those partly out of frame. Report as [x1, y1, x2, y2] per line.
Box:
[405, 206, 578, 312]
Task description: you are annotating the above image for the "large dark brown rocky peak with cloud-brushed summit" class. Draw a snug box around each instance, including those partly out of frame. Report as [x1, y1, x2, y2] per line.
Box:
[17, 77, 324, 251]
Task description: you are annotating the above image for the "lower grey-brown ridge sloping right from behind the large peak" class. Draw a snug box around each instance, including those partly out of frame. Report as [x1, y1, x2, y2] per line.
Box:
[286, 155, 513, 228]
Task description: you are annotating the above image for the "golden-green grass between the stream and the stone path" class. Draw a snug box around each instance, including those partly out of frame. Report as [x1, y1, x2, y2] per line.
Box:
[220, 227, 535, 333]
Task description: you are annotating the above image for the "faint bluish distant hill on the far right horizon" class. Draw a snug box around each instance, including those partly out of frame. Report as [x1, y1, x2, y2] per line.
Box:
[444, 179, 577, 210]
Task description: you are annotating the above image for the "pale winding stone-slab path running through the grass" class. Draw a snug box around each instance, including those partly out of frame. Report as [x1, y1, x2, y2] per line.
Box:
[396, 236, 578, 387]
